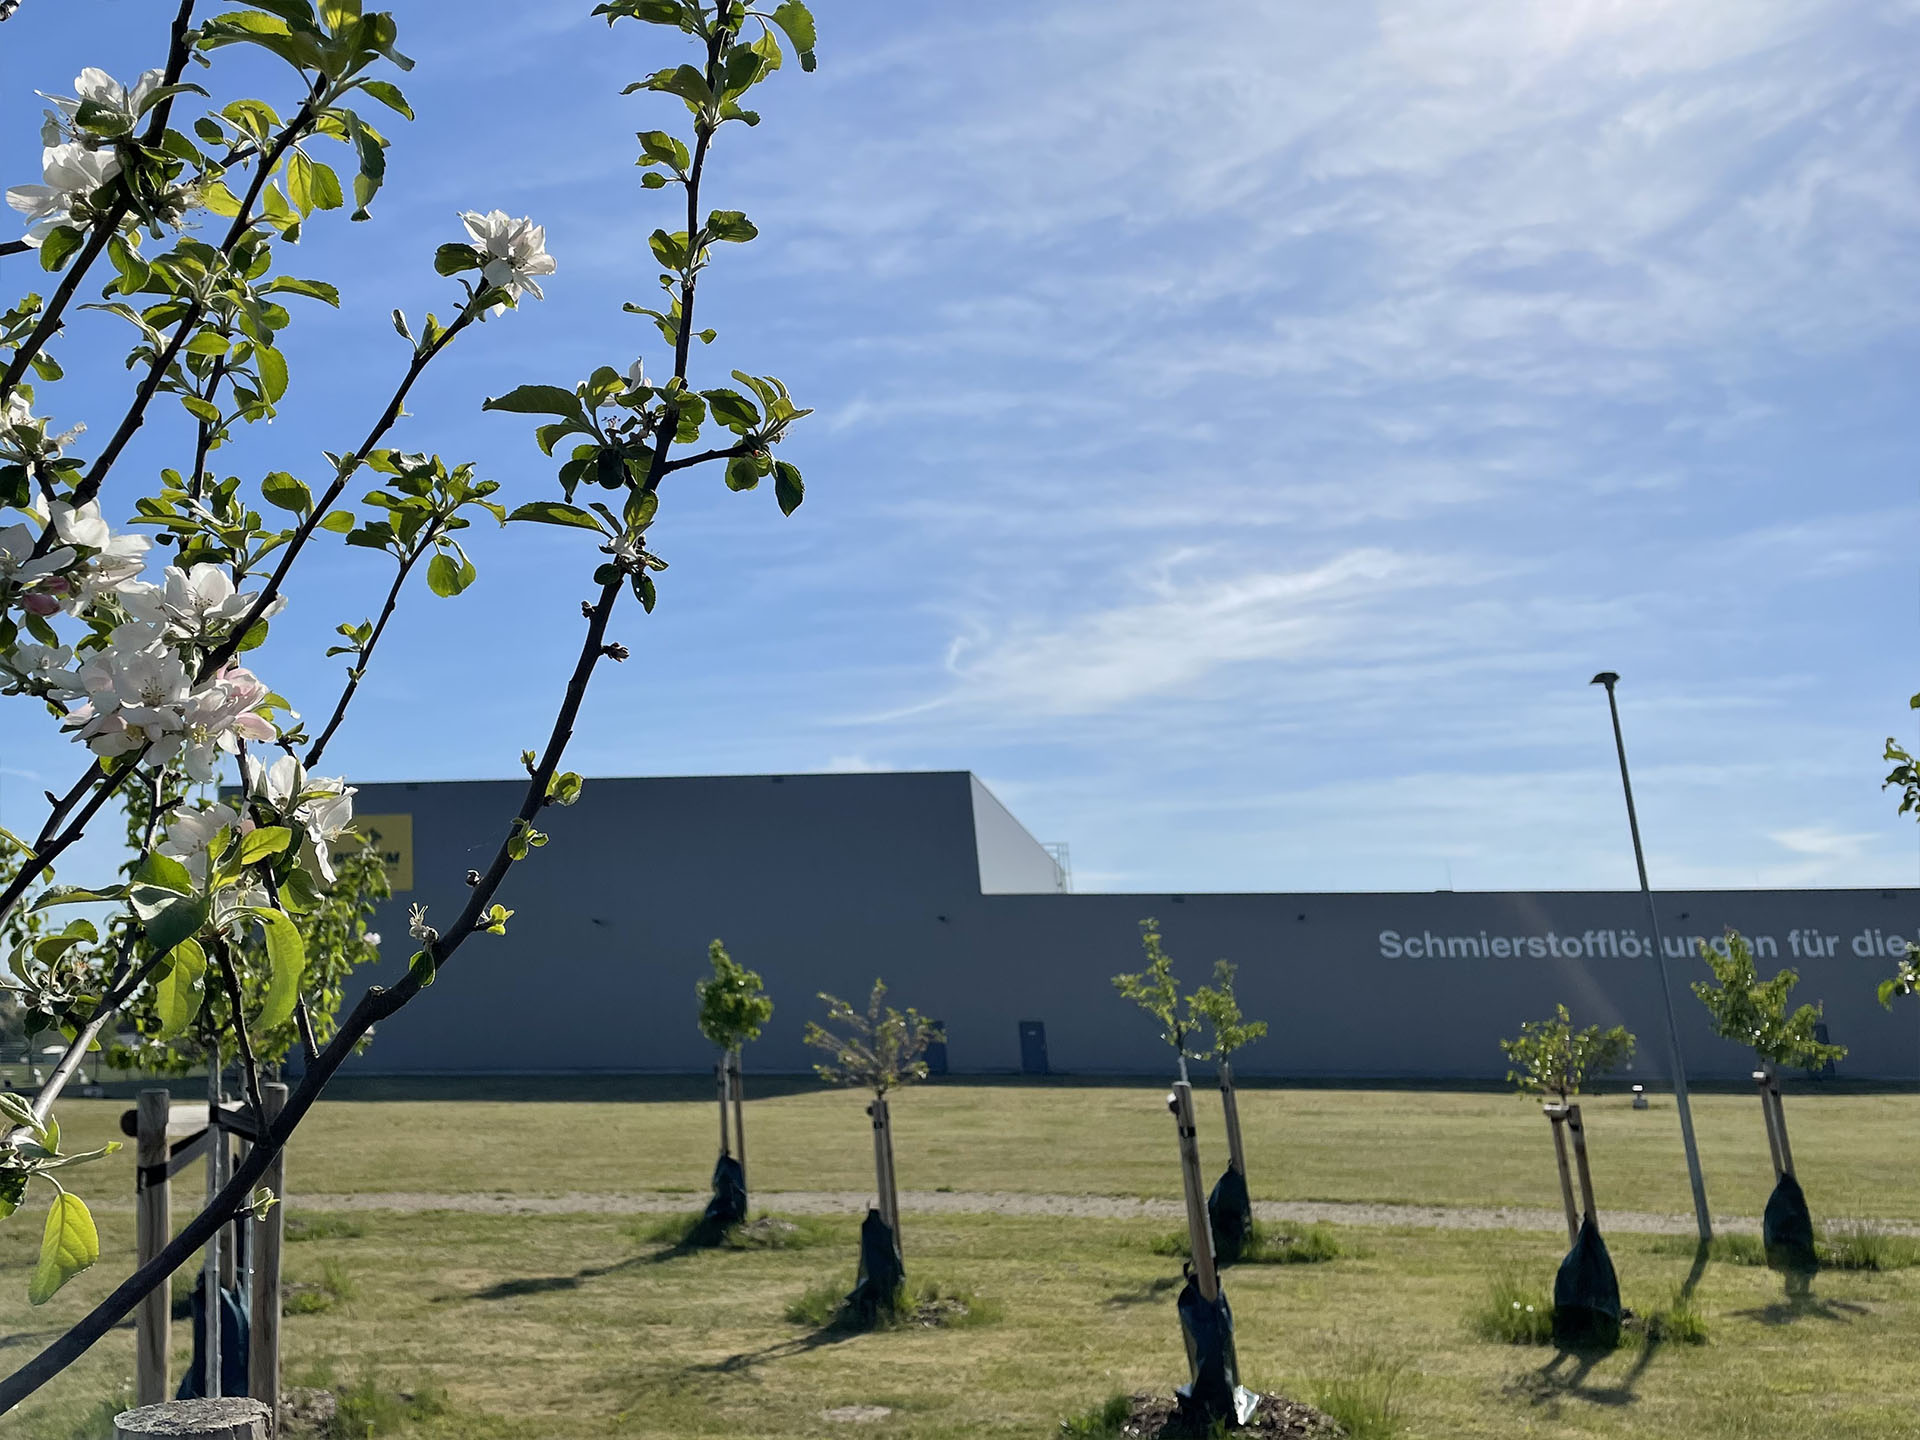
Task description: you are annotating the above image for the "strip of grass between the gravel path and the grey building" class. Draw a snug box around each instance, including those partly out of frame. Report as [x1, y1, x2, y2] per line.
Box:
[22, 1075, 1920, 1221]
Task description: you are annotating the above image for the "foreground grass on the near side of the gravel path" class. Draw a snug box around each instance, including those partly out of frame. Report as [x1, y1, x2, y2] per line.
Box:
[0, 1213, 1920, 1440]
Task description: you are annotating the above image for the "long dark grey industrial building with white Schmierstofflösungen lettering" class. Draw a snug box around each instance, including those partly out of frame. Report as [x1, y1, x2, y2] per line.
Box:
[355, 772, 1920, 1081]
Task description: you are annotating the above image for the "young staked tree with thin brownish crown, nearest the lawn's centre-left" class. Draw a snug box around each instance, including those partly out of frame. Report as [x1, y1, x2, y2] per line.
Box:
[804, 979, 943, 1315]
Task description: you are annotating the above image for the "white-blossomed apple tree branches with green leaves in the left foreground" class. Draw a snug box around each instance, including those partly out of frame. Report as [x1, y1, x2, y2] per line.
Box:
[0, 0, 814, 1411]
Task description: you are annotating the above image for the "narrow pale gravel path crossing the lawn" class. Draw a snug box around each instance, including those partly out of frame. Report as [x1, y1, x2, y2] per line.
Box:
[292, 1190, 1920, 1235]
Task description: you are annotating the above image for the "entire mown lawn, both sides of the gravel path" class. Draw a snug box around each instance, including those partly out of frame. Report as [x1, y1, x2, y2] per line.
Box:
[0, 1081, 1920, 1440]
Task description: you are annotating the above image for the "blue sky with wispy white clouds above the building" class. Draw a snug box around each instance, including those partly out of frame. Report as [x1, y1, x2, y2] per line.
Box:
[0, 0, 1920, 899]
